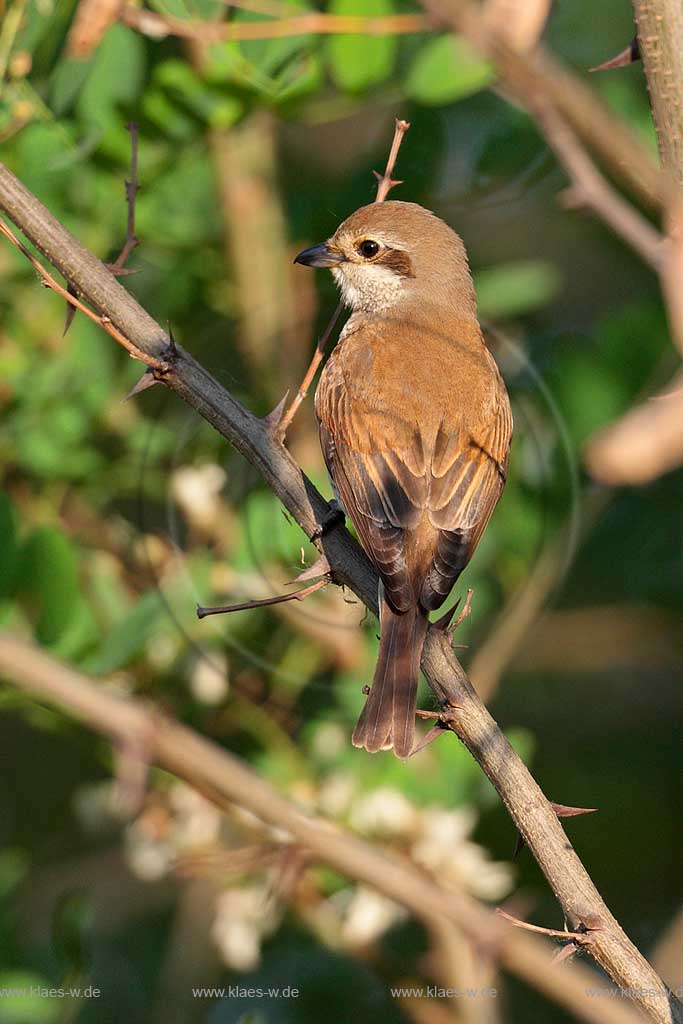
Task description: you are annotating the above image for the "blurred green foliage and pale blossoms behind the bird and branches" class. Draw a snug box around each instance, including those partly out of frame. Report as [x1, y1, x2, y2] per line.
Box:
[0, 0, 683, 1024]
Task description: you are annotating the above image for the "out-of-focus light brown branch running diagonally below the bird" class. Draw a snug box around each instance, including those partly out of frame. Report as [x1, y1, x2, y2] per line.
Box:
[0, 633, 642, 1024]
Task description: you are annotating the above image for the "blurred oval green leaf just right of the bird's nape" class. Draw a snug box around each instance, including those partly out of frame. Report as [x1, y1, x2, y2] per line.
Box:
[474, 260, 562, 318]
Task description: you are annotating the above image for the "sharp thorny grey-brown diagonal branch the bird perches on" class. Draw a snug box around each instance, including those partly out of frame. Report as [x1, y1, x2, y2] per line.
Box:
[0, 155, 683, 1024]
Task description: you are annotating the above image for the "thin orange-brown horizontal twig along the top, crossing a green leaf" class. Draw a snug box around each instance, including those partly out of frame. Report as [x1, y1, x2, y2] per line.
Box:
[120, 4, 432, 43]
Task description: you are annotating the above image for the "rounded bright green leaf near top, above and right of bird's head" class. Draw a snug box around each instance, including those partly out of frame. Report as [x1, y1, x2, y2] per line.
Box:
[405, 36, 494, 103]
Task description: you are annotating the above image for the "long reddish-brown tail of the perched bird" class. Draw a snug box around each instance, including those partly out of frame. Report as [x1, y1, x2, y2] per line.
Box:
[352, 600, 429, 758]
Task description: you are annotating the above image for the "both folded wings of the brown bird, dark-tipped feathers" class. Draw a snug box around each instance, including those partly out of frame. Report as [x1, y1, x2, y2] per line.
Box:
[315, 335, 512, 611]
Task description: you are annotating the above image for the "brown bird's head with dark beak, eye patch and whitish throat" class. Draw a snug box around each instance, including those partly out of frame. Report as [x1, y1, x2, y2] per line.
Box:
[294, 202, 476, 314]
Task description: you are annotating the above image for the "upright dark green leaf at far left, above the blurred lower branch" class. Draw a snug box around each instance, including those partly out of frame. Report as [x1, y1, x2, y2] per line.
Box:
[16, 526, 81, 645]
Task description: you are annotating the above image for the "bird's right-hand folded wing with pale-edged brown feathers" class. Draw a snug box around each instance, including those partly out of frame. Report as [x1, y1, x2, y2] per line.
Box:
[420, 380, 512, 610]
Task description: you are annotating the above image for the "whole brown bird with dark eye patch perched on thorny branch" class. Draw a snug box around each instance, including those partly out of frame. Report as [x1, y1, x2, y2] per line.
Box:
[295, 201, 512, 759]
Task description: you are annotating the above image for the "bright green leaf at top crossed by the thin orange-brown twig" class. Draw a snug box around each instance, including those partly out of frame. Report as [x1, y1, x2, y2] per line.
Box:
[326, 0, 397, 92]
